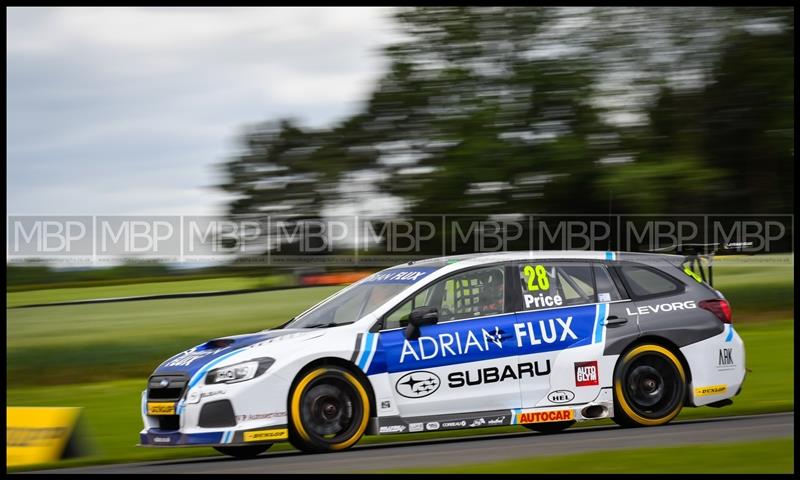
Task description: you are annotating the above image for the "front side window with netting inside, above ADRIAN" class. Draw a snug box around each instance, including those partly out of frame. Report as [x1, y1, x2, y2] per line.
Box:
[383, 266, 505, 329]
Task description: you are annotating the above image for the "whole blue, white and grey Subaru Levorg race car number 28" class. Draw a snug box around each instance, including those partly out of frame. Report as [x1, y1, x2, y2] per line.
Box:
[140, 251, 745, 457]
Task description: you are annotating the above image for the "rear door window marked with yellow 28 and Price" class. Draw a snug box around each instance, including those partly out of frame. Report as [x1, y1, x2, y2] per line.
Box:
[519, 262, 595, 310]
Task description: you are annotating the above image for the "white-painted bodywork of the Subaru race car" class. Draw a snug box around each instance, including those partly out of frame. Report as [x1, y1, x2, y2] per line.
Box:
[141, 252, 745, 445]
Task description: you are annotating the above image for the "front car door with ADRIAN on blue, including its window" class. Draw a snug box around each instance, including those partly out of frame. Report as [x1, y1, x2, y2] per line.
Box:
[378, 264, 520, 417]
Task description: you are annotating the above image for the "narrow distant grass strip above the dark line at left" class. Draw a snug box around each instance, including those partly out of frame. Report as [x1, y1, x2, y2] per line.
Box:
[6, 275, 291, 307]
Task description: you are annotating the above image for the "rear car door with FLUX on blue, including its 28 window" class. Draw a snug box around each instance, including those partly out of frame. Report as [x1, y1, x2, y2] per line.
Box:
[513, 260, 638, 407]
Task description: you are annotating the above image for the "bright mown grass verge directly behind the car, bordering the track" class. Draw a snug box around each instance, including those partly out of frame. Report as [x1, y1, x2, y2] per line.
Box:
[6, 320, 794, 466]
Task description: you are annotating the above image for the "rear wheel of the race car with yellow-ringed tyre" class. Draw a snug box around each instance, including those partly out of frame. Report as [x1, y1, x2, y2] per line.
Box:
[613, 343, 687, 427]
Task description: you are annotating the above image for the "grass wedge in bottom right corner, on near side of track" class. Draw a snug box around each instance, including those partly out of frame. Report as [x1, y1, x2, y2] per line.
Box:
[378, 438, 794, 474]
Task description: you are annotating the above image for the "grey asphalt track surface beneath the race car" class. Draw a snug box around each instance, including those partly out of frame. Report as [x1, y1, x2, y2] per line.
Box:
[26, 412, 794, 474]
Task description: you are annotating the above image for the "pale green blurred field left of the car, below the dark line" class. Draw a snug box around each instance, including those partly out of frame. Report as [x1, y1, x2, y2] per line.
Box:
[6, 287, 341, 385]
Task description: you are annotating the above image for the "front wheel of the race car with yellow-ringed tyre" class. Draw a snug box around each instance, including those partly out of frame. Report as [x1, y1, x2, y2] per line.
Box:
[289, 366, 370, 453]
